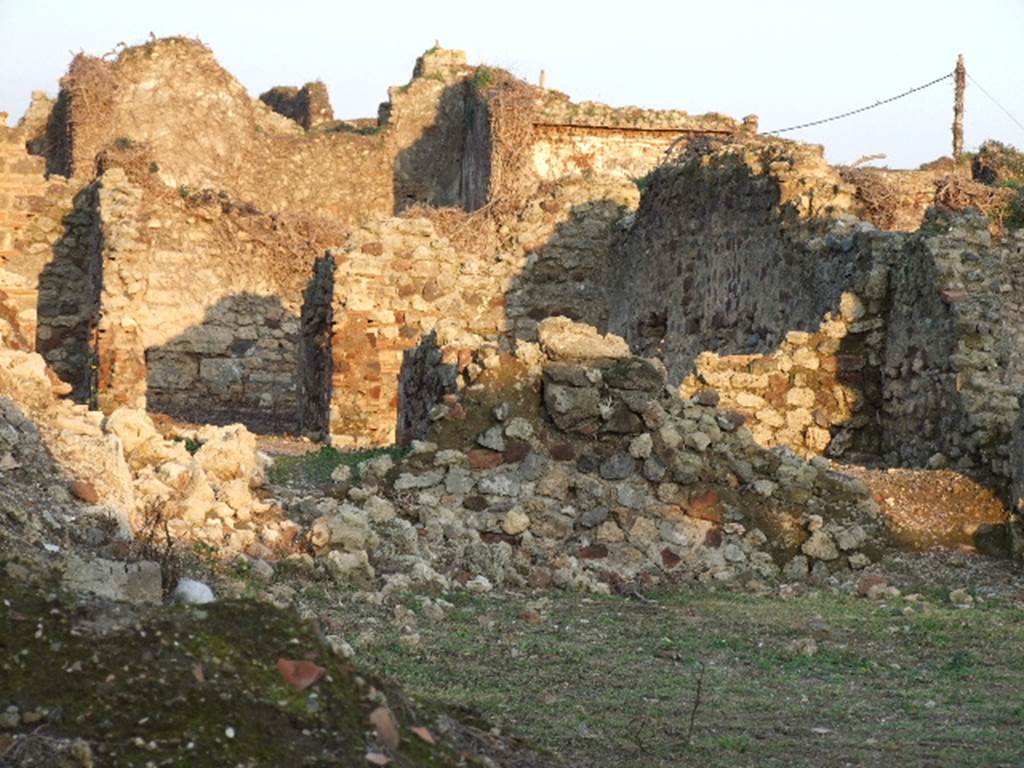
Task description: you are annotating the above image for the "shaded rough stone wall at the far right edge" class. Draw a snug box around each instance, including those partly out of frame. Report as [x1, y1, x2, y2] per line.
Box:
[885, 212, 1024, 482]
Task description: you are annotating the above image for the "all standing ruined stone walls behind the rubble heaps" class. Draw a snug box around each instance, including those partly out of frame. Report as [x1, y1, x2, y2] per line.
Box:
[0, 38, 1024, 561]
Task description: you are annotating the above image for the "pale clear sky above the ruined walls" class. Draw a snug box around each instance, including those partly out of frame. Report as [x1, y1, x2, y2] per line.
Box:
[0, 0, 1024, 168]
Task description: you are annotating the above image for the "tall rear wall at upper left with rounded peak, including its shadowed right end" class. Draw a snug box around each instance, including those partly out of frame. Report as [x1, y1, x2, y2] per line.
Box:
[39, 38, 544, 223]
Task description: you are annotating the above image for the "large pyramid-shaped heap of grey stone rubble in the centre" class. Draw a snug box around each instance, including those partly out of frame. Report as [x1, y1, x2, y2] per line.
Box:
[312, 317, 886, 591]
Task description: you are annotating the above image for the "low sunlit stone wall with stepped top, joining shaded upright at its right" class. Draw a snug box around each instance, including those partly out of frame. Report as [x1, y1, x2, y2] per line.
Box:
[680, 224, 898, 461]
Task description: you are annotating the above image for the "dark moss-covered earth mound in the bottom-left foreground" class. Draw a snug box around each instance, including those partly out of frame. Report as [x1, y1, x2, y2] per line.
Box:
[0, 577, 543, 768]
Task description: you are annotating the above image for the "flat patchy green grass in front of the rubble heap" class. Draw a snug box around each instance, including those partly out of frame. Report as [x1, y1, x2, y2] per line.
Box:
[347, 590, 1024, 768]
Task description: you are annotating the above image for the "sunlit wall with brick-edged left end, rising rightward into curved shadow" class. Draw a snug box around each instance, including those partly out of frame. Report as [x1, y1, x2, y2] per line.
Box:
[330, 171, 639, 445]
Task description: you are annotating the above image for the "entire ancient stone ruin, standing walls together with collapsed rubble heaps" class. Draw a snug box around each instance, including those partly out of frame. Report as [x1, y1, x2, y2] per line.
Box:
[0, 31, 1024, 587]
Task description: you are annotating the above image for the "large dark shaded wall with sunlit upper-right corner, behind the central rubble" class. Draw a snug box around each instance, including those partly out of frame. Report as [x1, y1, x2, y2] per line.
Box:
[609, 141, 855, 383]
